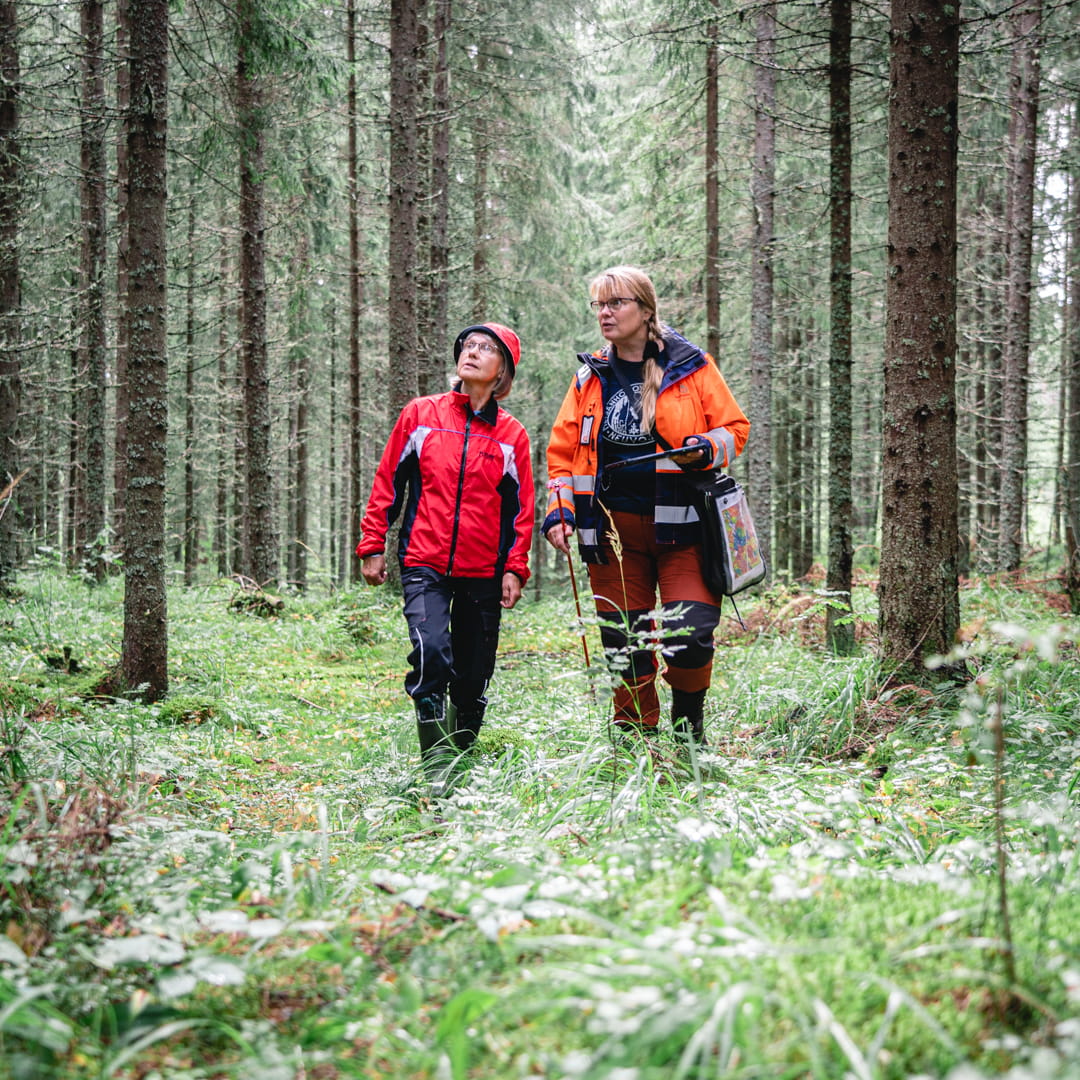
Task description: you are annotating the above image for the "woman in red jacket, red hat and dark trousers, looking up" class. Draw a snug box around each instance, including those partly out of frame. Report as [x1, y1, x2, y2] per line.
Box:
[356, 323, 534, 795]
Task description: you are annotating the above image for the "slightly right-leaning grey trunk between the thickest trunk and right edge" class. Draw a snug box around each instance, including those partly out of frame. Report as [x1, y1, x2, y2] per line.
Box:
[998, 0, 1042, 570]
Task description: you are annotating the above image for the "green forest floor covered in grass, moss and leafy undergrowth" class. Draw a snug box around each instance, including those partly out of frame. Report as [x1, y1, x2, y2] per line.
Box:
[0, 567, 1080, 1080]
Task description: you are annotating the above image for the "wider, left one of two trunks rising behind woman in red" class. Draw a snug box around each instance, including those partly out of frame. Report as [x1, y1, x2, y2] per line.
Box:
[388, 0, 419, 423]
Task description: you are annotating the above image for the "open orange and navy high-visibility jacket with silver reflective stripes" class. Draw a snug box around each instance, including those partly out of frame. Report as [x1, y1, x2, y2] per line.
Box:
[543, 330, 750, 563]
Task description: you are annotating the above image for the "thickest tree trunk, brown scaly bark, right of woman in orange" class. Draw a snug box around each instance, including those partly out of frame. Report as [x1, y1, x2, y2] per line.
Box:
[879, 0, 960, 678]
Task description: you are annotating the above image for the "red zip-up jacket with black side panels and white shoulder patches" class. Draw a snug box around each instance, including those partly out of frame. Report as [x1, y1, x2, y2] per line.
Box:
[356, 390, 534, 582]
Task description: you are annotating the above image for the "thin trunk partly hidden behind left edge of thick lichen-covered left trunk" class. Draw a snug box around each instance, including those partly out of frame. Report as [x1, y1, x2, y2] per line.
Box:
[112, 0, 131, 551]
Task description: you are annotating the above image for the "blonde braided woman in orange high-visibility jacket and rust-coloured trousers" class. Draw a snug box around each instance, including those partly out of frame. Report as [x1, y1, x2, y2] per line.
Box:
[543, 267, 750, 745]
